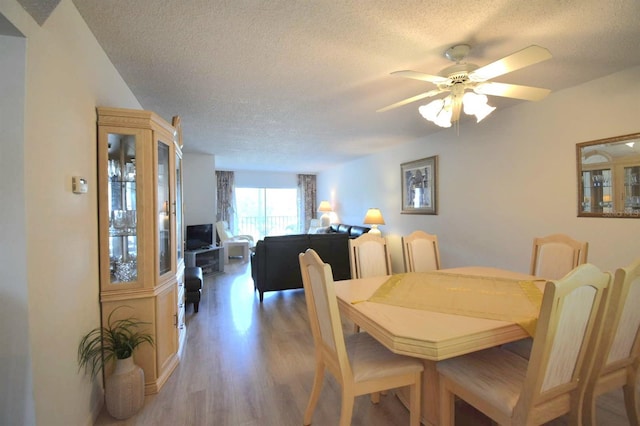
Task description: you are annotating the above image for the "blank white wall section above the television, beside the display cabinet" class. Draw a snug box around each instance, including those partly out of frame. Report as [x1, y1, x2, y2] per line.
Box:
[182, 153, 216, 225]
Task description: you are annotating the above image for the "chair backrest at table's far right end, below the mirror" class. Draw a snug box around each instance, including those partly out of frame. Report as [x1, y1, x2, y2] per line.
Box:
[531, 234, 589, 280]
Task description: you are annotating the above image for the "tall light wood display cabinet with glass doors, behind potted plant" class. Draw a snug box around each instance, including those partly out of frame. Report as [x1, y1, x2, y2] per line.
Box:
[98, 108, 186, 394]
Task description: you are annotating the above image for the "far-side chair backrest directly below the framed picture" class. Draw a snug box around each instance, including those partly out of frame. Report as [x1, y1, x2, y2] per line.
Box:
[402, 231, 440, 272]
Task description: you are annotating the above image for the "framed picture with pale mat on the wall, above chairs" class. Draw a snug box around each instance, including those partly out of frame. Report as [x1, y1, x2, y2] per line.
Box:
[400, 155, 438, 214]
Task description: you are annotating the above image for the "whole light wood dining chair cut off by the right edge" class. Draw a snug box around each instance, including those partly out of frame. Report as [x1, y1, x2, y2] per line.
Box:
[582, 260, 640, 426]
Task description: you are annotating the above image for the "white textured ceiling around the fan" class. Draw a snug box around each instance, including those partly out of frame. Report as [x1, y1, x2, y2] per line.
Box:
[67, 0, 640, 173]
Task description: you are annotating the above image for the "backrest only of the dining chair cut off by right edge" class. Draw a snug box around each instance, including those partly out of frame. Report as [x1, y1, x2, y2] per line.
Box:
[590, 259, 640, 382]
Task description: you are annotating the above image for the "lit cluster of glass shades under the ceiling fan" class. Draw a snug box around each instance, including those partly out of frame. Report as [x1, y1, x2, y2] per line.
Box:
[418, 90, 496, 127]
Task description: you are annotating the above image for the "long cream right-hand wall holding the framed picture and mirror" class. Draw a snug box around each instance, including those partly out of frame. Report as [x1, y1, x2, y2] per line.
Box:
[318, 67, 640, 272]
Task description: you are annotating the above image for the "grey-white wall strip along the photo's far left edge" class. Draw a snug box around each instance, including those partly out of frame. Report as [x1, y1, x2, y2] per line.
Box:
[0, 32, 35, 425]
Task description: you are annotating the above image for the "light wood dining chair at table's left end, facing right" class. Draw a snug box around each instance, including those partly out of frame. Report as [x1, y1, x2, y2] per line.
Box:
[299, 249, 424, 426]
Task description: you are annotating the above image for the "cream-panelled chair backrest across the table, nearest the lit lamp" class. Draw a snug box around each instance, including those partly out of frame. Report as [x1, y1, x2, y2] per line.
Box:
[349, 233, 391, 278]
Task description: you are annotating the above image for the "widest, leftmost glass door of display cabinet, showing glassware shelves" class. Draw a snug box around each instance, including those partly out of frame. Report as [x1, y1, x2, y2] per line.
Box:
[107, 133, 138, 284]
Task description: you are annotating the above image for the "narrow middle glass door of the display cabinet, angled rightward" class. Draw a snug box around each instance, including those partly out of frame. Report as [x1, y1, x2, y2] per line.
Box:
[157, 141, 172, 275]
